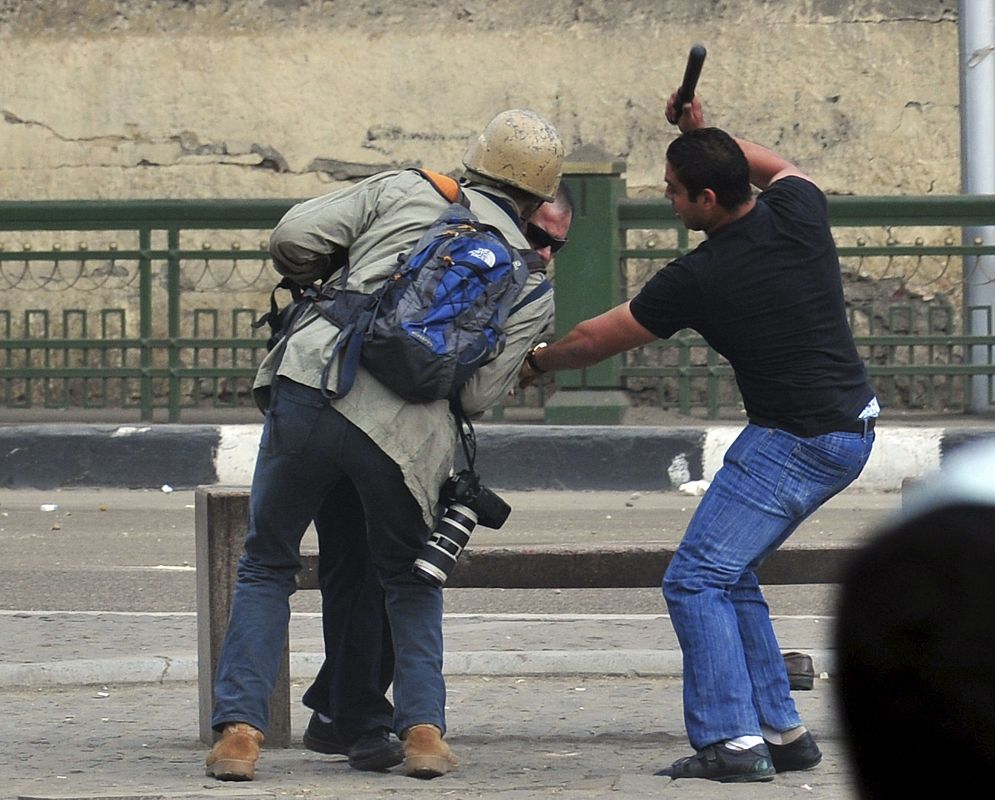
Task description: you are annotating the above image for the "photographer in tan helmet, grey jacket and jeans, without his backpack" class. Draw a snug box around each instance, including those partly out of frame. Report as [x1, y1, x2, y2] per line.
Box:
[207, 110, 563, 780]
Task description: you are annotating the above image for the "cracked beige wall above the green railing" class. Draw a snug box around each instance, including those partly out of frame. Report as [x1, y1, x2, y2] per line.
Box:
[0, 0, 960, 200]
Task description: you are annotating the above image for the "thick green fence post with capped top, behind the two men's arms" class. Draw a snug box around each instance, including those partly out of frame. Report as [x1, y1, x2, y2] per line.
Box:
[544, 147, 629, 425]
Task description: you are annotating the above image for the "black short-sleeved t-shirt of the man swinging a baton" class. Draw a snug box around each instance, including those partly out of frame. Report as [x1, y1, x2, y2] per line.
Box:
[630, 177, 874, 436]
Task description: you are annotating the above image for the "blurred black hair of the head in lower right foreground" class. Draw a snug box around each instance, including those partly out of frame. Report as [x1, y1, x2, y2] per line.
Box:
[835, 503, 995, 800]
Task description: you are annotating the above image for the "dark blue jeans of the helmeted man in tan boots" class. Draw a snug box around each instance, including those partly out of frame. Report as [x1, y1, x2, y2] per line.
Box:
[211, 378, 446, 733]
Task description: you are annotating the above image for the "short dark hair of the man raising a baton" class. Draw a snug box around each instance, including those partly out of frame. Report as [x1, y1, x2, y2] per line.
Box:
[667, 128, 753, 211]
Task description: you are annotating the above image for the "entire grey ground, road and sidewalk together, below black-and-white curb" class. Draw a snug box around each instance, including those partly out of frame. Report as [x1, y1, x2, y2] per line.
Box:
[0, 489, 900, 800]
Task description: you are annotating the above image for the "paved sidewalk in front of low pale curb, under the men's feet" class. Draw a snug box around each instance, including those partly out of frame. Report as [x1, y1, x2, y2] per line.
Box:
[0, 676, 855, 800]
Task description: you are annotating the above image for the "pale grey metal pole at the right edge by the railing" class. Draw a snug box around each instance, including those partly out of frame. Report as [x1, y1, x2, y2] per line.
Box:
[959, 0, 995, 413]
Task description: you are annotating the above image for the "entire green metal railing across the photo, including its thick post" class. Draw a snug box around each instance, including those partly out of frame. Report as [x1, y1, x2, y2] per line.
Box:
[0, 180, 995, 422]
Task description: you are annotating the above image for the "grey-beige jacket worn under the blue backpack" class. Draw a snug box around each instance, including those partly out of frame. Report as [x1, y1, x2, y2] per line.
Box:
[254, 170, 553, 524]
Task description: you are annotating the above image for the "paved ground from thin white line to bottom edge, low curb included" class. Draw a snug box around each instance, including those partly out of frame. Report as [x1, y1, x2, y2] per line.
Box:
[0, 612, 854, 800]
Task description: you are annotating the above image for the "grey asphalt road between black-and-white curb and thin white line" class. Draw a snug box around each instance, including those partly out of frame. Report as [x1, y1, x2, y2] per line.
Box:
[0, 489, 900, 614]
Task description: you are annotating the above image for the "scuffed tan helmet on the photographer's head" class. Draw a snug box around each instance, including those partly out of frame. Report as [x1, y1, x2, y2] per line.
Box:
[463, 108, 563, 200]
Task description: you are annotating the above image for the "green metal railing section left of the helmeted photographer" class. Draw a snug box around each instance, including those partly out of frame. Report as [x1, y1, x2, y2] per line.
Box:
[0, 200, 292, 421]
